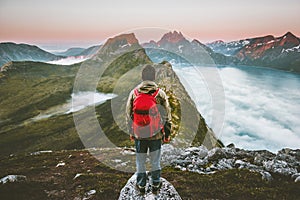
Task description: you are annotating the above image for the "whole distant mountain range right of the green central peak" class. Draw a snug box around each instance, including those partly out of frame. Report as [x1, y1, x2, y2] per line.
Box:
[143, 31, 300, 72]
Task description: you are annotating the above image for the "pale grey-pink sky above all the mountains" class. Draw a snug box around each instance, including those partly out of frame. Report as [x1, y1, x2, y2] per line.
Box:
[0, 0, 300, 50]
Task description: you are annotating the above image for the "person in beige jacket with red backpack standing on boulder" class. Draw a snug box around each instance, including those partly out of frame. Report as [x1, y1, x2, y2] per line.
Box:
[126, 65, 171, 193]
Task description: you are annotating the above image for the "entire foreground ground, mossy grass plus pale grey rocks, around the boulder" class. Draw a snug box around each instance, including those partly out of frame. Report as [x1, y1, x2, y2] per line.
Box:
[0, 145, 300, 200]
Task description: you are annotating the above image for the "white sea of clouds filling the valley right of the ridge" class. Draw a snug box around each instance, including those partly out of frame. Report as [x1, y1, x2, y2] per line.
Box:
[174, 67, 300, 152]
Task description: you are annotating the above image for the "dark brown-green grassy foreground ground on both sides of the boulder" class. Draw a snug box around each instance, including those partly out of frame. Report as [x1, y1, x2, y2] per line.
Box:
[0, 151, 300, 200]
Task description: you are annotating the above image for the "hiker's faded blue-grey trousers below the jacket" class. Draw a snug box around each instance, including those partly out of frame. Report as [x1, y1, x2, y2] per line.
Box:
[135, 140, 161, 187]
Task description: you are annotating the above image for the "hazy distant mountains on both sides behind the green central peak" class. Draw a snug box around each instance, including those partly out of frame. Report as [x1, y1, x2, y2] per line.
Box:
[0, 31, 300, 72]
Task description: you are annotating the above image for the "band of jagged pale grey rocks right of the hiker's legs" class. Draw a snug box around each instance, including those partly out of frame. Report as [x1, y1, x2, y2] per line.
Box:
[162, 145, 300, 182]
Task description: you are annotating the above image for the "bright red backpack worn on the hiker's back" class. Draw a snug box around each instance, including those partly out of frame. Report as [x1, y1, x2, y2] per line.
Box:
[133, 89, 163, 138]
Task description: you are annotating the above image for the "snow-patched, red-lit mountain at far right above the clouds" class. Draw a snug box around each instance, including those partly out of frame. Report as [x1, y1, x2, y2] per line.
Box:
[206, 32, 300, 72]
